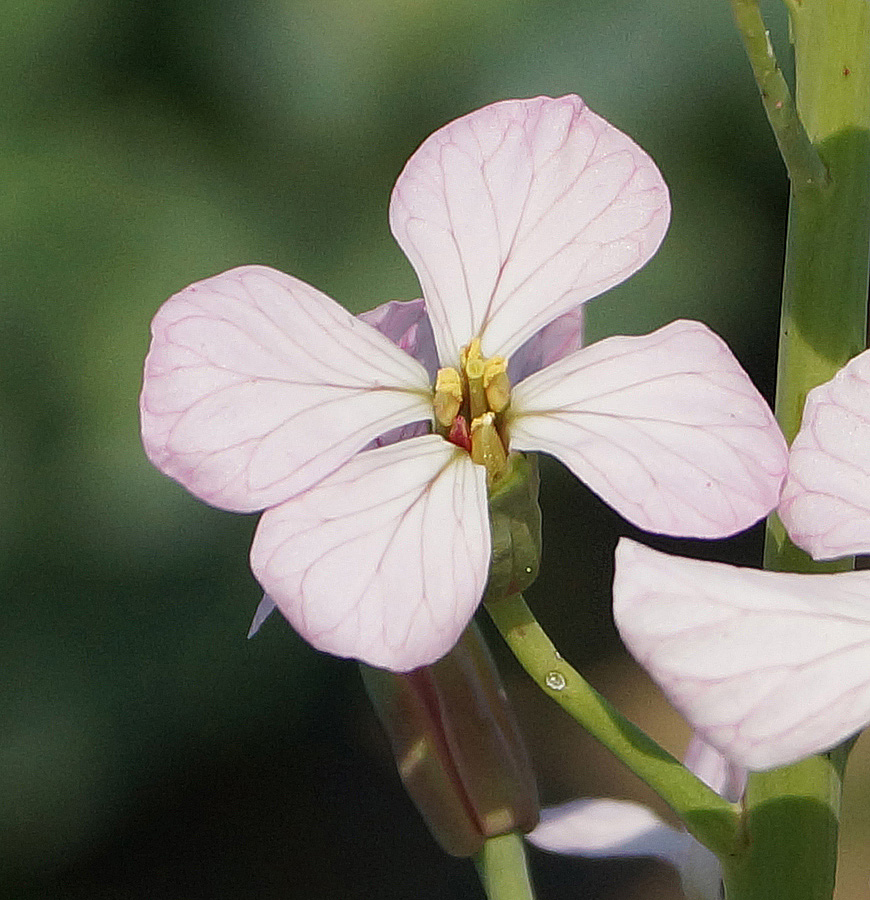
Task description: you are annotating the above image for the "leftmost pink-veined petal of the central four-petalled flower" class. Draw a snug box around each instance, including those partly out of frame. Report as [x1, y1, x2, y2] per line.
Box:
[140, 266, 431, 512]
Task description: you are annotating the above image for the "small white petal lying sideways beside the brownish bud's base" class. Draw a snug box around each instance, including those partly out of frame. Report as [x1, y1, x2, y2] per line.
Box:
[528, 800, 692, 865]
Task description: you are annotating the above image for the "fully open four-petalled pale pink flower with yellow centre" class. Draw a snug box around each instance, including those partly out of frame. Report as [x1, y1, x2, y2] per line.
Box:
[141, 96, 785, 670]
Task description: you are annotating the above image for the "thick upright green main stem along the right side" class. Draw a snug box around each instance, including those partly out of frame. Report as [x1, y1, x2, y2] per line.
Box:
[724, 0, 870, 900]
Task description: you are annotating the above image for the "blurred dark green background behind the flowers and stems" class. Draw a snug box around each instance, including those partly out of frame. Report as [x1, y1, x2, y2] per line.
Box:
[0, 0, 870, 900]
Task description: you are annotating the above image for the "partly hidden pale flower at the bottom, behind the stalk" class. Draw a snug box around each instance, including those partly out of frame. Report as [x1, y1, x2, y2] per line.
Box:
[528, 737, 746, 900]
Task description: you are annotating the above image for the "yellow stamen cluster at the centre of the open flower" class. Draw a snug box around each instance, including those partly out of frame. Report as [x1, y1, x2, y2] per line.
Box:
[433, 338, 511, 485]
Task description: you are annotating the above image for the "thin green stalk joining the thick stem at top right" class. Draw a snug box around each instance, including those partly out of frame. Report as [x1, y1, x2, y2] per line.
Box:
[731, 0, 828, 186]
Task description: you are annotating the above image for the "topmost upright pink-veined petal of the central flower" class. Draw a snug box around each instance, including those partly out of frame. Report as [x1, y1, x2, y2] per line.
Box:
[390, 96, 670, 366]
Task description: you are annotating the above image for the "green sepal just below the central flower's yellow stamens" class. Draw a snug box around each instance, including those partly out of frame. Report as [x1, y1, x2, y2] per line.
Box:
[483, 453, 541, 603]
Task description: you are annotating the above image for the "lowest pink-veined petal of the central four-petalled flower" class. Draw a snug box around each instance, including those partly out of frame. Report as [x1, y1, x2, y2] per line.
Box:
[251, 435, 490, 671]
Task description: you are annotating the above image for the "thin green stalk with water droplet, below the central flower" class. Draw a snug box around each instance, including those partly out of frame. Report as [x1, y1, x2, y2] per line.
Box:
[487, 594, 742, 858]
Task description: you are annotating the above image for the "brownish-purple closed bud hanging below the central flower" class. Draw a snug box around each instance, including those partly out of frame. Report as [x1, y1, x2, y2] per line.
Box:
[361, 622, 539, 856]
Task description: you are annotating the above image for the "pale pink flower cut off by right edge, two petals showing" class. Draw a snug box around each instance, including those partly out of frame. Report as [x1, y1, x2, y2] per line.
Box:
[613, 353, 870, 770]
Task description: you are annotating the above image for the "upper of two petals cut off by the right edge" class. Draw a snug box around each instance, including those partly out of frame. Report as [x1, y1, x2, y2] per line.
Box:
[779, 351, 870, 559]
